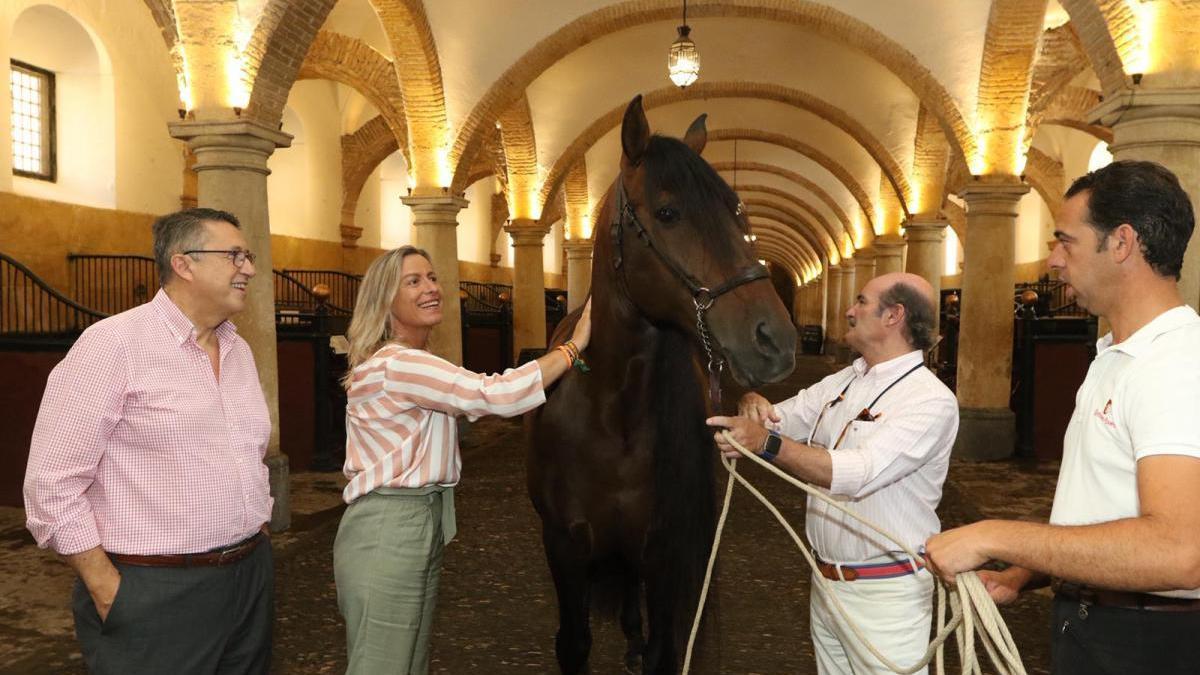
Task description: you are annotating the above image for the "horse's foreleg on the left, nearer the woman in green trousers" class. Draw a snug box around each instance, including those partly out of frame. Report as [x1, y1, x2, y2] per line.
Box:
[542, 525, 592, 675]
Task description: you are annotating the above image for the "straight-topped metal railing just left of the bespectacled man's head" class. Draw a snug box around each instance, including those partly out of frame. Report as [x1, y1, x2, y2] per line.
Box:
[67, 253, 158, 313]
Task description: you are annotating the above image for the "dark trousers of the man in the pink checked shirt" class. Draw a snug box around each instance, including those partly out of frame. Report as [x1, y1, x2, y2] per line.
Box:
[72, 540, 275, 675]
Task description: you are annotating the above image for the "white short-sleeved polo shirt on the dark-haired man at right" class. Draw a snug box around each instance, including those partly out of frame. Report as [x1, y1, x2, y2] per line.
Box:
[1050, 305, 1200, 597]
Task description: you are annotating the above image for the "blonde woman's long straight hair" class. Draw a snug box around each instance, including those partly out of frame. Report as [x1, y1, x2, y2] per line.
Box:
[342, 246, 433, 389]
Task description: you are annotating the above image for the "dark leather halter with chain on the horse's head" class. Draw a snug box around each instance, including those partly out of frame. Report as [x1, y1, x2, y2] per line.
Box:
[611, 177, 769, 412]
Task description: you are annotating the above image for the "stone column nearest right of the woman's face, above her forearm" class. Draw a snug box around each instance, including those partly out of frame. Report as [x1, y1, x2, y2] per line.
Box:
[504, 219, 550, 354]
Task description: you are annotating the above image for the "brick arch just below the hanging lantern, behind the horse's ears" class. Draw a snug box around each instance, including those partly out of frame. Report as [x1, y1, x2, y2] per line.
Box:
[541, 82, 912, 213]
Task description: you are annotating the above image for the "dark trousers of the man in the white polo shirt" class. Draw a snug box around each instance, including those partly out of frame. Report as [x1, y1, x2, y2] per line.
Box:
[1051, 597, 1200, 675]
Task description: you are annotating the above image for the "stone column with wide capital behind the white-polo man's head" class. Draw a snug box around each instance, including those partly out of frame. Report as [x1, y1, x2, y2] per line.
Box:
[1090, 86, 1200, 307]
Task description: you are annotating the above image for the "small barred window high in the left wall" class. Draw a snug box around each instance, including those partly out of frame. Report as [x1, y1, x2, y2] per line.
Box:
[8, 60, 56, 181]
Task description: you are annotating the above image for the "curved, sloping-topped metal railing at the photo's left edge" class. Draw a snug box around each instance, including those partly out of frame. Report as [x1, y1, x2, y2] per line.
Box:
[0, 253, 108, 342]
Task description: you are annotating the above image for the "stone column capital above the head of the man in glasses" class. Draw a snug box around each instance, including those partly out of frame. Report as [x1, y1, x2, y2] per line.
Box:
[167, 120, 292, 175]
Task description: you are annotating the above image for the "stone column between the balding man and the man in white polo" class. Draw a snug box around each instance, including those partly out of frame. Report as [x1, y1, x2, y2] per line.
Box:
[954, 178, 1030, 460]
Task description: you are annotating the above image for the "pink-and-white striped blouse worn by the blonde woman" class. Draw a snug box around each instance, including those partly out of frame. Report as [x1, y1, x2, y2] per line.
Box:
[342, 345, 546, 503]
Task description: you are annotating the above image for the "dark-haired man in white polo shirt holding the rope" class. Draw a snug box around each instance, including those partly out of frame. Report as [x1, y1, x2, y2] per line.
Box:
[926, 162, 1200, 675]
